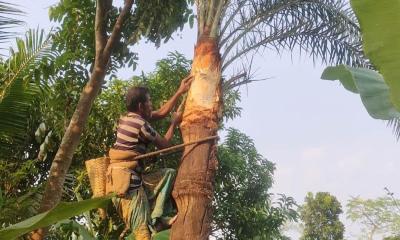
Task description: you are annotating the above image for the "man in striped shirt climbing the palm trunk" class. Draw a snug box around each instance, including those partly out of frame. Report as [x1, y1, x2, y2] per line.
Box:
[107, 76, 192, 240]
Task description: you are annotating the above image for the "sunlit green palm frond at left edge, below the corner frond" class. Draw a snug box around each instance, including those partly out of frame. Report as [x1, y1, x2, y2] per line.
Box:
[0, 29, 56, 144]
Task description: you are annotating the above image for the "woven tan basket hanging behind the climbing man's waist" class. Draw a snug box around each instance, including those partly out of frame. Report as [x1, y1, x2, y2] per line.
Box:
[85, 157, 110, 197]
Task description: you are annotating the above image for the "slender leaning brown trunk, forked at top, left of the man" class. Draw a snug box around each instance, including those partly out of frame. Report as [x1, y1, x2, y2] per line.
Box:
[30, 0, 133, 240]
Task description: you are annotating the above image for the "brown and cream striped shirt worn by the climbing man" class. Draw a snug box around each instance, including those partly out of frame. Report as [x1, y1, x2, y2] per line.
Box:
[113, 112, 157, 153]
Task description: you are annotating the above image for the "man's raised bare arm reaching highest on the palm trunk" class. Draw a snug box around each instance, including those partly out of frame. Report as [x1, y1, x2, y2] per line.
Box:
[151, 75, 193, 120]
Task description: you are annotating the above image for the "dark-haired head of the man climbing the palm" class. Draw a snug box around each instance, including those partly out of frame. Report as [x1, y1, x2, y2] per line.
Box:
[125, 87, 153, 119]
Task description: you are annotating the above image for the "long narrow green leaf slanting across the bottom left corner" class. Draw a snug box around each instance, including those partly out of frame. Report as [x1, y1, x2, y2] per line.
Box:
[0, 195, 113, 240]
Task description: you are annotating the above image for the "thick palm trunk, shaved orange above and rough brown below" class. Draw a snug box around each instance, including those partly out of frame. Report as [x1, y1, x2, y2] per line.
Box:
[171, 34, 221, 240]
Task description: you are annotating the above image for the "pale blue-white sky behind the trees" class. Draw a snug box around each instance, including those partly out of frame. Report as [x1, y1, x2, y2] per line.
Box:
[13, 0, 400, 239]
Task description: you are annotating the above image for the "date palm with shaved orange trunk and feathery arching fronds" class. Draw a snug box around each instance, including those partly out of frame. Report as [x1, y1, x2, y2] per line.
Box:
[171, 0, 364, 240]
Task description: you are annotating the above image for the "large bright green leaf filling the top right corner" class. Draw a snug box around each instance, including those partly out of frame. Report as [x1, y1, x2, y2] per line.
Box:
[350, 0, 400, 111]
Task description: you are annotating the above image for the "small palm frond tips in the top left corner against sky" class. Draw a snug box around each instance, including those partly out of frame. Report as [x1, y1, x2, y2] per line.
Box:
[0, 1, 24, 42]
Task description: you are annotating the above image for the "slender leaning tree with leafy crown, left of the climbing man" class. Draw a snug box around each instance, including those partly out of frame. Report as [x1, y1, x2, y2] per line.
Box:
[31, 0, 190, 240]
